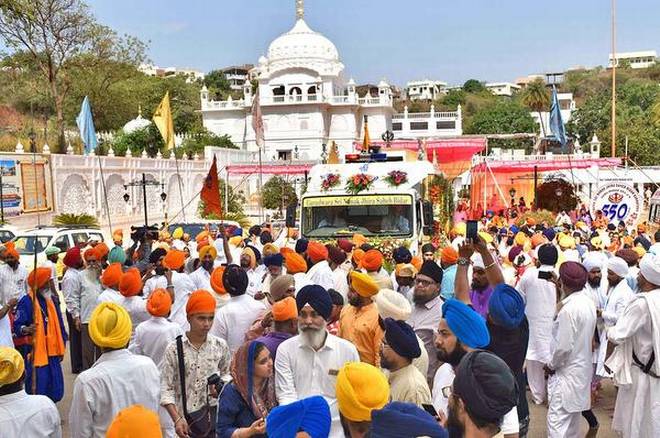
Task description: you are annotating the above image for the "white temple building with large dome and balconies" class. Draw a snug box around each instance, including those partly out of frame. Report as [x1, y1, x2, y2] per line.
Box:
[200, 0, 462, 160]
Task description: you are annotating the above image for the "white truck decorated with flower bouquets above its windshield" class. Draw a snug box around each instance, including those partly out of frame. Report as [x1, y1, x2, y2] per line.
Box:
[300, 153, 435, 254]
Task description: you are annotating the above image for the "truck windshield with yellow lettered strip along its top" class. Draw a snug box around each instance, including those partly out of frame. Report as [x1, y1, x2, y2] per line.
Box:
[302, 195, 414, 238]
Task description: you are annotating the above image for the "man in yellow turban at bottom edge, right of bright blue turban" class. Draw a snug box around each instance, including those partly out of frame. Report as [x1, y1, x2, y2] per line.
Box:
[336, 362, 390, 436]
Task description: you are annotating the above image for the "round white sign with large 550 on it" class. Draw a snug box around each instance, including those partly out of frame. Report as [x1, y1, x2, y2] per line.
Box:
[590, 181, 644, 227]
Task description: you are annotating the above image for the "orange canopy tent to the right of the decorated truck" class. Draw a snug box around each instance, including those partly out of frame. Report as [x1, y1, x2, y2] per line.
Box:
[470, 156, 621, 218]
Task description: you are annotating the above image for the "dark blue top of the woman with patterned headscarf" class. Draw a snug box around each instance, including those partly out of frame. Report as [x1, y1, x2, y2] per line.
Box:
[215, 383, 265, 438]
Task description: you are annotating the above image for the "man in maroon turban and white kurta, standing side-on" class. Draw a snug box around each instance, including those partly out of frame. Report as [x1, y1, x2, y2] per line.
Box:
[545, 262, 596, 438]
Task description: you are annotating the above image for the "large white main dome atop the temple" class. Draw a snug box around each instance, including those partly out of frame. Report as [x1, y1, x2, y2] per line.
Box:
[268, 19, 339, 62]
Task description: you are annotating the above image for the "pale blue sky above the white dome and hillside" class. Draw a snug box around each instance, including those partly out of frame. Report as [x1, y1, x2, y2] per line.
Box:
[88, 0, 660, 86]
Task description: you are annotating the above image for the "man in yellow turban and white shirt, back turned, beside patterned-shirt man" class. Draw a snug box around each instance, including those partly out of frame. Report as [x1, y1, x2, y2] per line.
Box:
[69, 303, 160, 437]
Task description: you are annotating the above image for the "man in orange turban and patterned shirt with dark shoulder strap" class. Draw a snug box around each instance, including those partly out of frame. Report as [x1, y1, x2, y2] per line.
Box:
[160, 290, 230, 436]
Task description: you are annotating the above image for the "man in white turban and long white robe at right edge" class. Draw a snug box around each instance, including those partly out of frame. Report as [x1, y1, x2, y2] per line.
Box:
[606, 254, 660, 438]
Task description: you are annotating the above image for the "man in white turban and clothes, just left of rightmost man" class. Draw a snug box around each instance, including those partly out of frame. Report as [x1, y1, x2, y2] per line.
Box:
[596, 257, 635, 377]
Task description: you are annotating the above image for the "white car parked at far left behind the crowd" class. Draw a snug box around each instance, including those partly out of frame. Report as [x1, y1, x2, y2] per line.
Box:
[13, 226, 105, 277]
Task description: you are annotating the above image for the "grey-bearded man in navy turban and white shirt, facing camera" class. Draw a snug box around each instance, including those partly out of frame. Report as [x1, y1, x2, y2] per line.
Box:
[275, 285, 360, 438]
